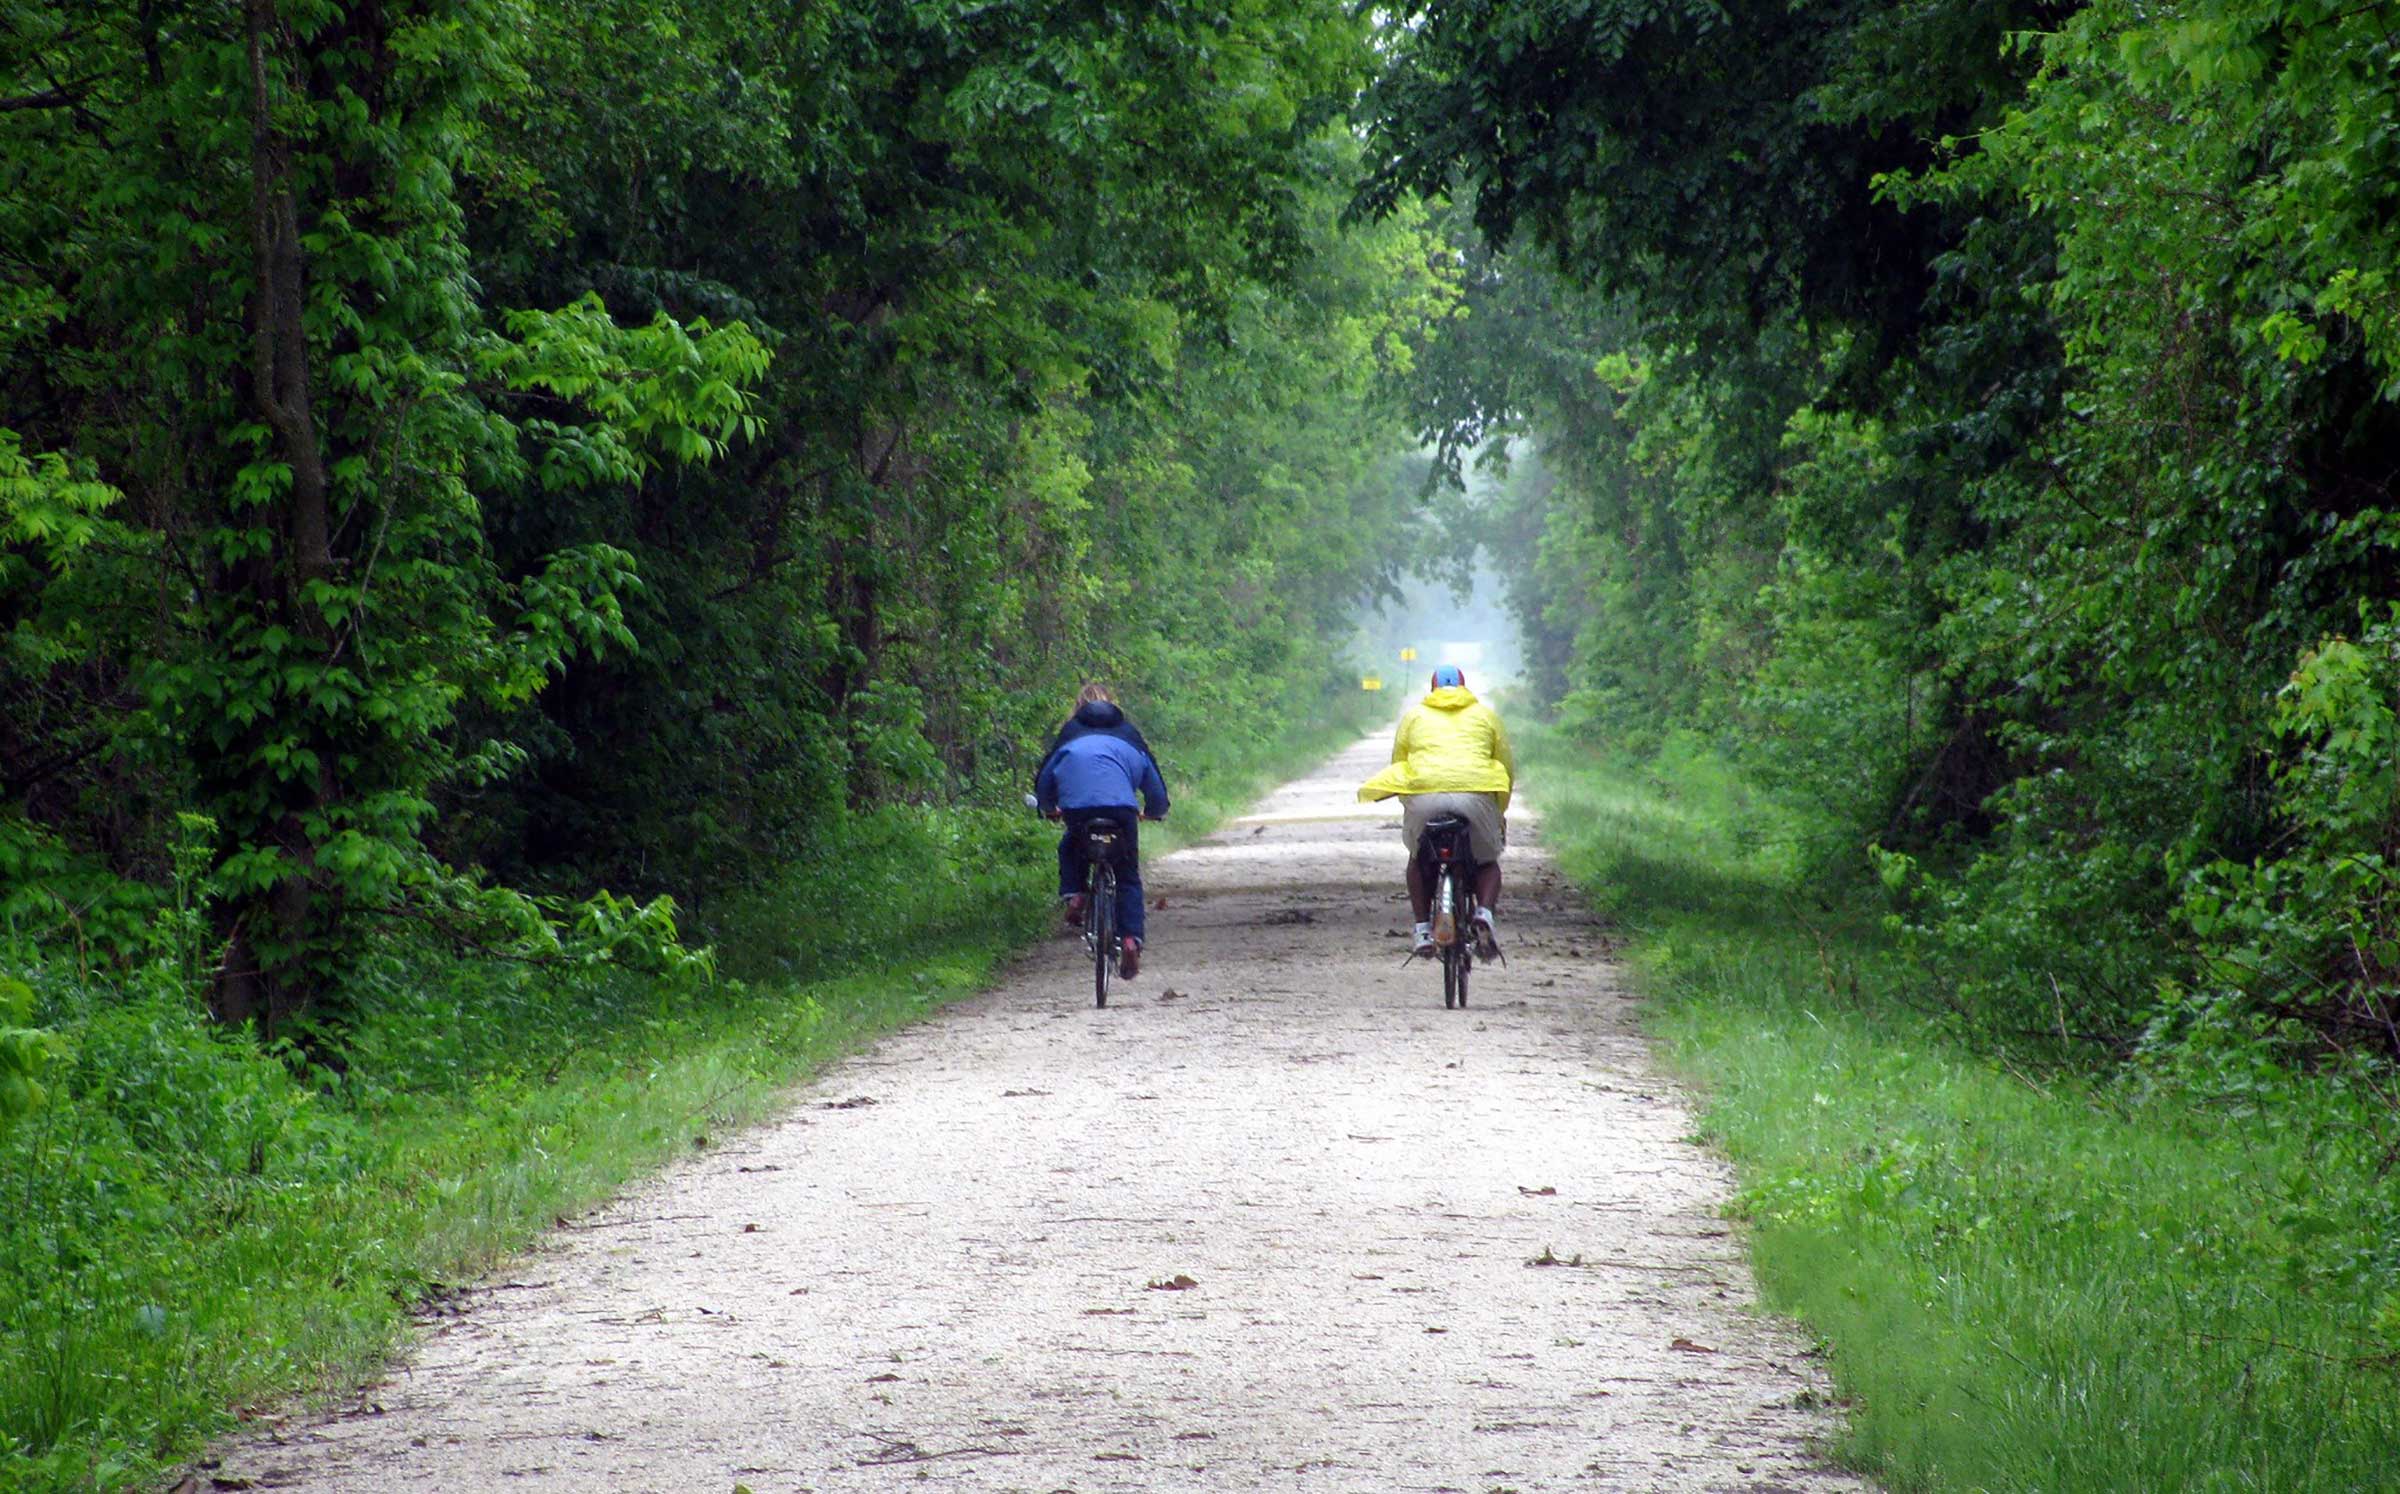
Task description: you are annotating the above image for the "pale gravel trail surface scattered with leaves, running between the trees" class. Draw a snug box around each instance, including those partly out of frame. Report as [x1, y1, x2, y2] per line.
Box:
[214, 733, 1860, 1494]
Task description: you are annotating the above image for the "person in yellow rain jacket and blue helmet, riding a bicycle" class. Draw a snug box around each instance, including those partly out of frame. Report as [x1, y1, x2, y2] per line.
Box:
[1358, 663, 1517, 958]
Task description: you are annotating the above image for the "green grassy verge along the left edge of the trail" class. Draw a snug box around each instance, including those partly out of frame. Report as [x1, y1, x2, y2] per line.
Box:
[0, 701, 1358, 1494]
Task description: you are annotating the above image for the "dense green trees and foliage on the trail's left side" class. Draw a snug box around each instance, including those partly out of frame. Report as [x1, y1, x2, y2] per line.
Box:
[0, 0, 1447, 1026]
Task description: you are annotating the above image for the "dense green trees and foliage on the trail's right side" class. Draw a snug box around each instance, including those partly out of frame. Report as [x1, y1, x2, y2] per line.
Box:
[1363, 0, 2400, 1083]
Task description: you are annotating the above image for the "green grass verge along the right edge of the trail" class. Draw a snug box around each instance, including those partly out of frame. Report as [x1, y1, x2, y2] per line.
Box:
[1524, 728, 2400, 1492]
